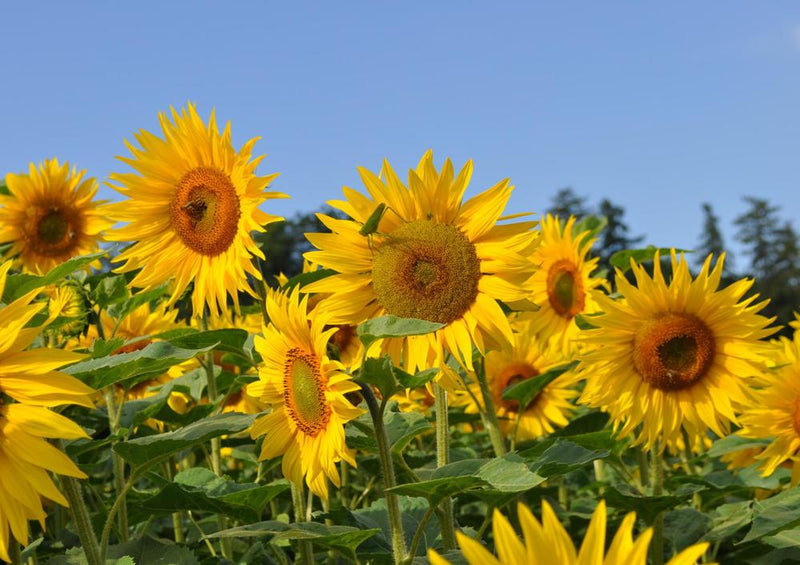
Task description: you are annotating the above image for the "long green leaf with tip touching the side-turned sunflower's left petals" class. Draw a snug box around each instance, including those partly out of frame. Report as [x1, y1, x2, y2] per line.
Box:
[114, 412, 256, 467]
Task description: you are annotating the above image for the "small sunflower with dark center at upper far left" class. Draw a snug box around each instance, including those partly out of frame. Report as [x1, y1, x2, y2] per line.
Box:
[0, 159, 111, 274]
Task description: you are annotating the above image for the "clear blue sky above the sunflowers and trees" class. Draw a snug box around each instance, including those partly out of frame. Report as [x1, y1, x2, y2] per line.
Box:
[0, 1, 800, 262]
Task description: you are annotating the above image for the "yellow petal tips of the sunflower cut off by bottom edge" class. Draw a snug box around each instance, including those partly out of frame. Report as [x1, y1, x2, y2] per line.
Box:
[428, 500, 708, 565]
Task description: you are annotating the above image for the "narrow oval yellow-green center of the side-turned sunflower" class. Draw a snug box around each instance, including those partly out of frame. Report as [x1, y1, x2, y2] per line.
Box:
[283, 348, 331, 436]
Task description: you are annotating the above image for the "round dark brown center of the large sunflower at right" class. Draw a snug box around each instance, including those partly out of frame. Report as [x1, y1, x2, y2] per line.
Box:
[633, 312, 716, 391]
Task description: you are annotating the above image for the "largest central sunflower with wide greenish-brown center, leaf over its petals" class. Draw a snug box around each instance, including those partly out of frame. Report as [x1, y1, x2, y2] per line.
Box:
[305, 151, 537, 371]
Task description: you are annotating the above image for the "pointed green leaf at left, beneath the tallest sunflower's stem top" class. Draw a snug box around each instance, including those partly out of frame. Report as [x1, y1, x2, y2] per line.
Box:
[62, 341, 212, 390]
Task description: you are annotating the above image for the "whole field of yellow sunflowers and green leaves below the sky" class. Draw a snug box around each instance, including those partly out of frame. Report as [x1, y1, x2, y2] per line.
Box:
[0, 104, 800, 565]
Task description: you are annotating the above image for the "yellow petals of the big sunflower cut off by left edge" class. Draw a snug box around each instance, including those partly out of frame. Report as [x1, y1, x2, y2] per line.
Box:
[0, 261, 94, 561]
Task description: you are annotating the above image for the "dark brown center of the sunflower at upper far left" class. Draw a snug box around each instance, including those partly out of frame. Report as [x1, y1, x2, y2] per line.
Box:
[26, 205, 81, 257]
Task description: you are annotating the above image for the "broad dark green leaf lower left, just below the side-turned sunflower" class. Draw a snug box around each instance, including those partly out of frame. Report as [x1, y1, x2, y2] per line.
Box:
[137, 467, 289, 522]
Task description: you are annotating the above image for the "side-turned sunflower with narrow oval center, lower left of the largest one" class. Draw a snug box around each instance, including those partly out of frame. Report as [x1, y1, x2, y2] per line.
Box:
[247, 290, 362, 499]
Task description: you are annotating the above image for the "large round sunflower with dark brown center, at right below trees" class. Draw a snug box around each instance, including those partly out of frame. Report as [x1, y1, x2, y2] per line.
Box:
[580, 251, 774, 449]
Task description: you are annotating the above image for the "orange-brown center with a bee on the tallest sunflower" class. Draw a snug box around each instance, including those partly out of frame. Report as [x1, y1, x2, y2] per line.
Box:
[170, 167, 241, 257]
